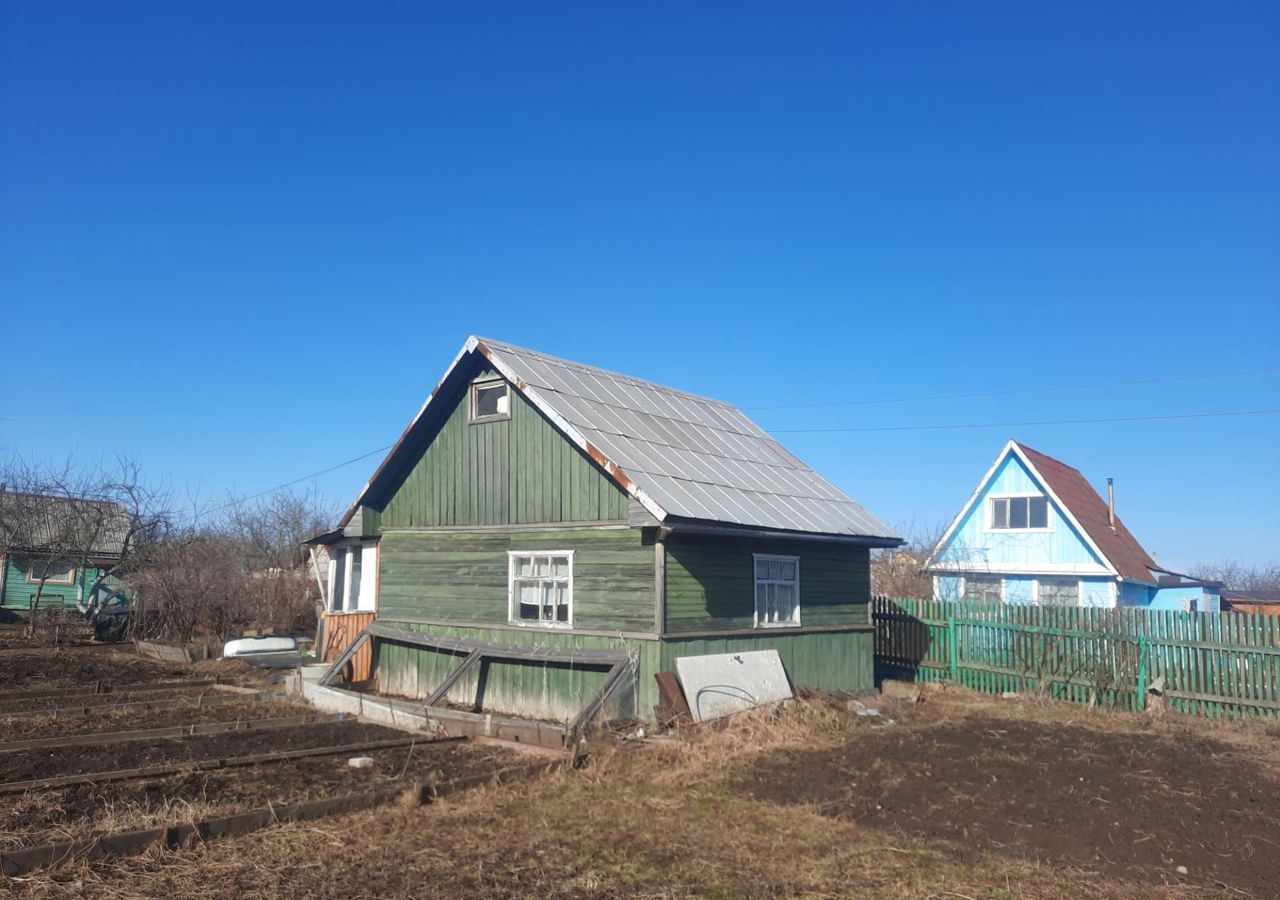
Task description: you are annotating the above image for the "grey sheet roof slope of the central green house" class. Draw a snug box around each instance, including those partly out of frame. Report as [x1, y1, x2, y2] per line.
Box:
[474, 338, 897, 539]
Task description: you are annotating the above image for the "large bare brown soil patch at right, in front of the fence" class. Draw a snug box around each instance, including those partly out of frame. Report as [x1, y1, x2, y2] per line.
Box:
[736, 717, 1280, 896]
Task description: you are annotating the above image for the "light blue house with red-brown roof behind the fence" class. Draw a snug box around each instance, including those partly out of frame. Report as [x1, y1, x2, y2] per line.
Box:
[925, 440, 1221, 612]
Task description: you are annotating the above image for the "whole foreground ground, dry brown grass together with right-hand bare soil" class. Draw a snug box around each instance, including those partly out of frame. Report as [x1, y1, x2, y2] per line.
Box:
[5, 690, 1280, 900]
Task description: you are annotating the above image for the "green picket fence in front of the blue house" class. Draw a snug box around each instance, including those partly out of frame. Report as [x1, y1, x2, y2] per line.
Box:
[872, 597, 1280, 718]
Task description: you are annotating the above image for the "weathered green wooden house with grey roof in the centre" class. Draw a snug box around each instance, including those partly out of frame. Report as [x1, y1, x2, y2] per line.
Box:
[328, 337, 901, 721]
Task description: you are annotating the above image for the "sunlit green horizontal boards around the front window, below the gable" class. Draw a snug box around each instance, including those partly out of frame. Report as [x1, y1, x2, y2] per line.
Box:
[379, 527, 655, 636]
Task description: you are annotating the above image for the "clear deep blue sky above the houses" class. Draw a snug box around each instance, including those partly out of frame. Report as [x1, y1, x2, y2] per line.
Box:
[0, 0, 1280, 566]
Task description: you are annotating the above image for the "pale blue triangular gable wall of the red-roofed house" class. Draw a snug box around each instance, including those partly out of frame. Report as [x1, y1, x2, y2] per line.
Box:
[937, 452, 1105, 571]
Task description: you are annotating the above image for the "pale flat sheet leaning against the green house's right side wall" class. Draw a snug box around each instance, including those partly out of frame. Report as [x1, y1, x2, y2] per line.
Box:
[676, 650, 792, 722]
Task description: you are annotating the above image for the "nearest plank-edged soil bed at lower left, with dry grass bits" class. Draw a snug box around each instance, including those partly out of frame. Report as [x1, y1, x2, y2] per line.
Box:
[0, 737, 527, 848]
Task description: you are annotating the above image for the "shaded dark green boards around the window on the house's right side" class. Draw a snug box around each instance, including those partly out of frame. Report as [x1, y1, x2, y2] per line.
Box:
[666, 535, 870, 634]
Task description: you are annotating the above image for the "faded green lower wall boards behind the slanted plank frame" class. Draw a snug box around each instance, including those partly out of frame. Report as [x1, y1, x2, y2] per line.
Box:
[376, 616, 658, 722]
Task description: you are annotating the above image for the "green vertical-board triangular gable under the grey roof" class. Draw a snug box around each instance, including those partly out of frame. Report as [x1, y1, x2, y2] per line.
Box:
[380, 371, 627, 527]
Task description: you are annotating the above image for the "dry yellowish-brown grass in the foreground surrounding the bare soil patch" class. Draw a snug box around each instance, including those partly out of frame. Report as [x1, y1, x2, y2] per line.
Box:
[9, 691, 1276, 900]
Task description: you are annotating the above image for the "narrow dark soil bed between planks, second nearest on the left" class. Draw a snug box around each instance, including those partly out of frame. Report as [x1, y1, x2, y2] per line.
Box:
[3, 721, 406, 782]
